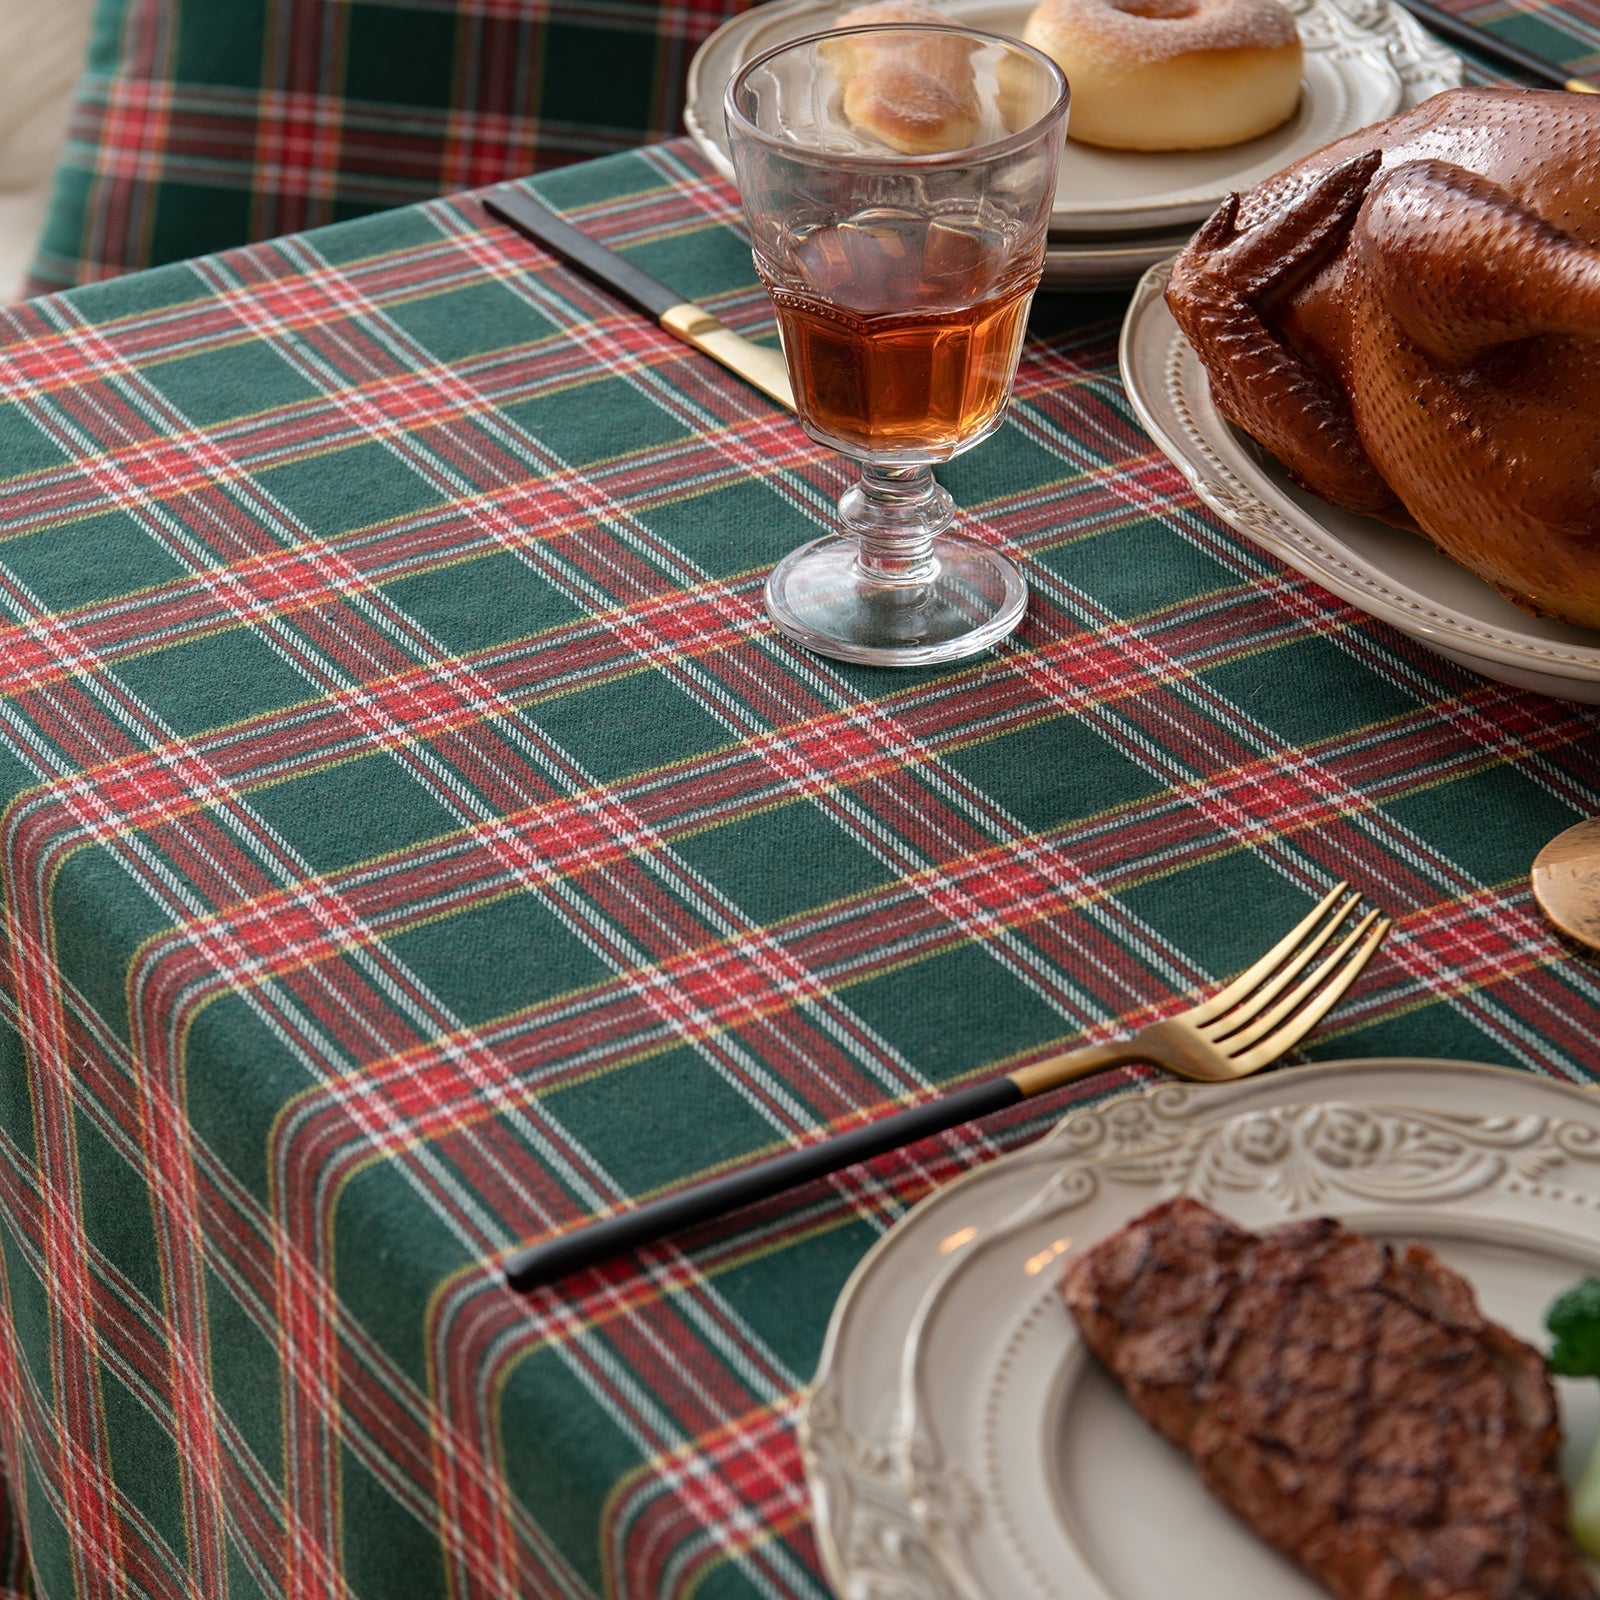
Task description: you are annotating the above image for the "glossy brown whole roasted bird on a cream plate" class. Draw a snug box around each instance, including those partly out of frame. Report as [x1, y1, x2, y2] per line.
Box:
[1166, 88, 1600, 627]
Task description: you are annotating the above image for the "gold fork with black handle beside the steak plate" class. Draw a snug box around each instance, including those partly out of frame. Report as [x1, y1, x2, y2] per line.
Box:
[506, 883, 1390, 1290]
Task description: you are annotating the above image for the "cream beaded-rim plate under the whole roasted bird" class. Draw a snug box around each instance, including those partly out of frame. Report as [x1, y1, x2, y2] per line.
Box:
[1120, 264, 1600, 704]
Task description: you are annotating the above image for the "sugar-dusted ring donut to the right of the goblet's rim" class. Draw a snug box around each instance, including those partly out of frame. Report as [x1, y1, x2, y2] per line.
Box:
[1022, 0, 1301, 150]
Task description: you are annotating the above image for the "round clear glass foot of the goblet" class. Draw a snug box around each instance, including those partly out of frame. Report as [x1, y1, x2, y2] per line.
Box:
[766, 534, 1027, 667]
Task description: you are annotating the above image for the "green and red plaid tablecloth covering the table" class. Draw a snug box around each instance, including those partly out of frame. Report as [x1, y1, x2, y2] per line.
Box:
[0, 15, 1600, 1600]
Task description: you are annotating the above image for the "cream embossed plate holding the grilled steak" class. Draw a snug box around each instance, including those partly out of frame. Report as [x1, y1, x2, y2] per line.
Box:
[800, 1059, 1600, 1600]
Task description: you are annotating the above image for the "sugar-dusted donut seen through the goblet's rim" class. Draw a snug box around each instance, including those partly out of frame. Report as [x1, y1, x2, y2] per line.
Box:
[822, 0, 979, 155]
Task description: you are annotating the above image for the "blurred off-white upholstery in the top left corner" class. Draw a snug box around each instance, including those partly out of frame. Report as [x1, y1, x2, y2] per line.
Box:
[0, 0, 94, 304]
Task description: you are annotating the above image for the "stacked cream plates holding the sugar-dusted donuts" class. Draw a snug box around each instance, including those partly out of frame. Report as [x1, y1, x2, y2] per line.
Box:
[683, 0, 1462, 290]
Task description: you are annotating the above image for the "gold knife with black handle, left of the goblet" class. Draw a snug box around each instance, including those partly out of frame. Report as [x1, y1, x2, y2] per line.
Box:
[483, 189, 795, 411]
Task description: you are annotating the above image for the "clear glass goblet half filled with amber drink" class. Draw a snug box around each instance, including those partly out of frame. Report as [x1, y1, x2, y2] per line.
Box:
[725, 24, 1067, 666]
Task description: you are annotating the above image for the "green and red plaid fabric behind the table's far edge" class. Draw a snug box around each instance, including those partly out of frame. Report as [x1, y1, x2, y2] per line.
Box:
[32, 0, 752, 293]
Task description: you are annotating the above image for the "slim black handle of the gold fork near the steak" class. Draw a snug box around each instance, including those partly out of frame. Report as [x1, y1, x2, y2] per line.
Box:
[506, 1077, 1022, 1290]
